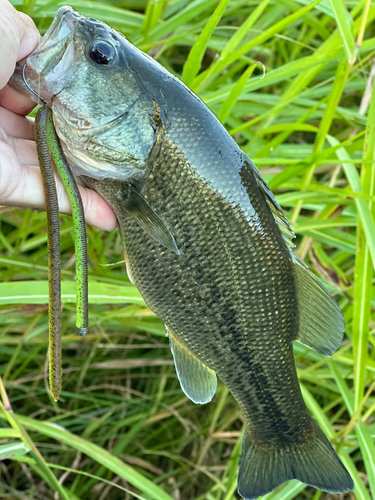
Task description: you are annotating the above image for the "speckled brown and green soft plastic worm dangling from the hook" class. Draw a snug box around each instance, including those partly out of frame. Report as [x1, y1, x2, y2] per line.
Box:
[23, 64, 88, 401]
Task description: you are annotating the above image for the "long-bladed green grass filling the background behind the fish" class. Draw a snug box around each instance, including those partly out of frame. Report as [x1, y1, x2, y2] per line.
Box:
[0, 0, 375, 500]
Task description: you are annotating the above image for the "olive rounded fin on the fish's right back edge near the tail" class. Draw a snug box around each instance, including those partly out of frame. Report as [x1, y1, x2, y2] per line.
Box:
[293, 255, 345, 356]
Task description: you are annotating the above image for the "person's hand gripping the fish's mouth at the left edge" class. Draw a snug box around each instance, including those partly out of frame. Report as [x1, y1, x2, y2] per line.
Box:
[0, 0, 116, 231]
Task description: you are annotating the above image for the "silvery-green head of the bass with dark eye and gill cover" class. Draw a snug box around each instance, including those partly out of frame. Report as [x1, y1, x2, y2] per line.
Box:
[10, 7, 160, 180]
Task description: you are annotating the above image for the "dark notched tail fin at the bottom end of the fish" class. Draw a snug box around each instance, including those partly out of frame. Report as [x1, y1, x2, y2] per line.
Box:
[238, 421, 354, 500]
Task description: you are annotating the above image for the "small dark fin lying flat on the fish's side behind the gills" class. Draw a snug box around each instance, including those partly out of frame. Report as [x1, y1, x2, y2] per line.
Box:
[125, 185, 180, 255]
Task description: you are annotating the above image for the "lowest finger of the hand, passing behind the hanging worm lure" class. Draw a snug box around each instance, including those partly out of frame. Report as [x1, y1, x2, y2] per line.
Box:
[0, 142, 116, 231]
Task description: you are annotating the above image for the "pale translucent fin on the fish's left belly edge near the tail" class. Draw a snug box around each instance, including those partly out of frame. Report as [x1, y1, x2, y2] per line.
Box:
[167, 328, 217, 404]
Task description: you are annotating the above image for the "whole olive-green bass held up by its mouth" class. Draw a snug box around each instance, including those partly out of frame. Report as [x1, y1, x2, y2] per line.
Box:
[11, 7, 354, 500]
